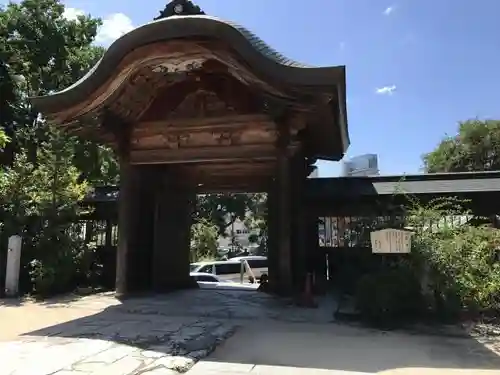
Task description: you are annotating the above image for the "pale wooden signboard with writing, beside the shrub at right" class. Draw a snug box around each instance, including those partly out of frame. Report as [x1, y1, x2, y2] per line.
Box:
[370, 229, 413, 254]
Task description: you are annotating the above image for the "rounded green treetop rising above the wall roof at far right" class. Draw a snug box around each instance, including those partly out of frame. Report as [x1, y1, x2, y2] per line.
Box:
[423, 119, 500, 173]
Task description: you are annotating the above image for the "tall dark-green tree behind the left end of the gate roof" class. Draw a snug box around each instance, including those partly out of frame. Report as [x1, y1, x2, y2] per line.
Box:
[0, 0, 118, 183]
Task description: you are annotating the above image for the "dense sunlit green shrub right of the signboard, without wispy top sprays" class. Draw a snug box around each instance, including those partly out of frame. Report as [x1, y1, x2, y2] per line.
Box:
[413, 225, 500, 318]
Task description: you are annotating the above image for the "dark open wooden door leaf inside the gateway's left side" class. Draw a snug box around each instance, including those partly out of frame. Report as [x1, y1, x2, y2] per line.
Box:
[151, 166, 196, 292]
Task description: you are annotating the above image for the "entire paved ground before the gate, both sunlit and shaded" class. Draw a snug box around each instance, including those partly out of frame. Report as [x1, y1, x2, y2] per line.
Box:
[0, 290, 500, 375]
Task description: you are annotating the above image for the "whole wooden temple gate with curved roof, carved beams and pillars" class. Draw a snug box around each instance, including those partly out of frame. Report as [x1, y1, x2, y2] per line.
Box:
[31, 0, 349, 295]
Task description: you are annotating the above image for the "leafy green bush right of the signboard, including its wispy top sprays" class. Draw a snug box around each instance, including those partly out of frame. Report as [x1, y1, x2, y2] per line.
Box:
[409, 199, 500, 316]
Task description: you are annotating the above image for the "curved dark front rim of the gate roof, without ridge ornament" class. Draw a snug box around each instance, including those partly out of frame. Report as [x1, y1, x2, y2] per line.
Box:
[31, 15, 345, 113]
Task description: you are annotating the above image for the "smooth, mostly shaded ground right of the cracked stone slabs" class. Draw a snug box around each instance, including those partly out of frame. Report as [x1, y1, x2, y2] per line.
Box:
[189, 322, 500, 375]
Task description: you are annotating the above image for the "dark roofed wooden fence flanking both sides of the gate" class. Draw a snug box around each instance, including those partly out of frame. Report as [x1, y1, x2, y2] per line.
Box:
[76, 172, 500, 293]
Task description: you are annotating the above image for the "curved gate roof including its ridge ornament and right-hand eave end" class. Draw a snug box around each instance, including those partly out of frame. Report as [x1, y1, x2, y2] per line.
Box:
[30, 4, 349, 160]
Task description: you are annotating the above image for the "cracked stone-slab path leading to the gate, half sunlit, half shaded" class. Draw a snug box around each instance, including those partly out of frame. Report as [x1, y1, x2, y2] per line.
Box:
[0, 290, 333, 375]
